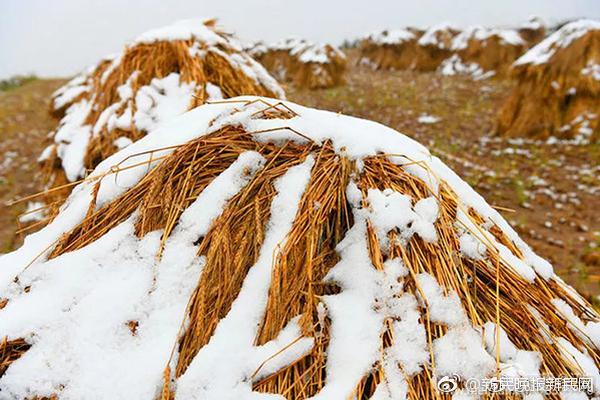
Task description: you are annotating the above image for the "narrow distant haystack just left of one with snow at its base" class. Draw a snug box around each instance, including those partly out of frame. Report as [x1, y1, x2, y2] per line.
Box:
[414, 23, 459, 71]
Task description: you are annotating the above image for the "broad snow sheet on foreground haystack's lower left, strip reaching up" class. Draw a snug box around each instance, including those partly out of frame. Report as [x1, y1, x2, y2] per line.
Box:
[0, 152, 264, 400]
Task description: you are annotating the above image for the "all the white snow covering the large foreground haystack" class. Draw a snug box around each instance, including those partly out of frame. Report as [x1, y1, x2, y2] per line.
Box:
[0, 93, 600, 400]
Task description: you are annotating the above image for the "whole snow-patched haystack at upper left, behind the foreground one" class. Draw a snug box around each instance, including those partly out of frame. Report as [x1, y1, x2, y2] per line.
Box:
[40, 20, 284, 214]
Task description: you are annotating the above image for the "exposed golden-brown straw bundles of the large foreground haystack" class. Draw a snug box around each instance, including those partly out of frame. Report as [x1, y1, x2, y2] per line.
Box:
[0, 100, 600, 400]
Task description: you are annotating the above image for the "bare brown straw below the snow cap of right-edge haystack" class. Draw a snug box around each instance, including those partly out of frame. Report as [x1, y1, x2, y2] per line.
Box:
[496, 30, 600, 141]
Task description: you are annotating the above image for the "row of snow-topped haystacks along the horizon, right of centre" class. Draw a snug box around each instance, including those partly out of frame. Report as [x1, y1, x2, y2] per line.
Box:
[359, 19, 545, 79]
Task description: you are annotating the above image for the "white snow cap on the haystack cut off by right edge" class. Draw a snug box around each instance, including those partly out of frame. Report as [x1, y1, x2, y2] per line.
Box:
[514, 19, 600, 65]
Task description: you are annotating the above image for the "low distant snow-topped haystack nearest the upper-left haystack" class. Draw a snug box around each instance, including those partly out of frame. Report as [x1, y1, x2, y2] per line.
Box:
[248, 38, 346, 89]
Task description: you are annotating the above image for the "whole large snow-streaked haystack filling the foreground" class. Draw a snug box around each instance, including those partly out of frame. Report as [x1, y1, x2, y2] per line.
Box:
[0, 97, 600, 400]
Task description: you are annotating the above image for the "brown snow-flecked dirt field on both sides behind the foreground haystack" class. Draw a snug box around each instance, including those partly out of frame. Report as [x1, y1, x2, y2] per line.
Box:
[0, 68, 600, 300]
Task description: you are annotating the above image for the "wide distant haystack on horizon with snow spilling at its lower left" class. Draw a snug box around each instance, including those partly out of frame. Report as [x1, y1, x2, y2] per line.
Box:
[439, 26, 527, 79]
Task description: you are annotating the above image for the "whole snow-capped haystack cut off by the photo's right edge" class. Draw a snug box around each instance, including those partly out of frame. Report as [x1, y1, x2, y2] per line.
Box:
[497, 20, 600, 143]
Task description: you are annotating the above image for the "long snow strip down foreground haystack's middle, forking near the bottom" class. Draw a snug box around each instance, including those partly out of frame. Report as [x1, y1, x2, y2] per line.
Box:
[176, 156, 314, 400]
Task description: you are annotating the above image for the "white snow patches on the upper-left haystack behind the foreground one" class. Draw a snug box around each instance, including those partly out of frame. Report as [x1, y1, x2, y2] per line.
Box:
[45, 19, 284, 182]
